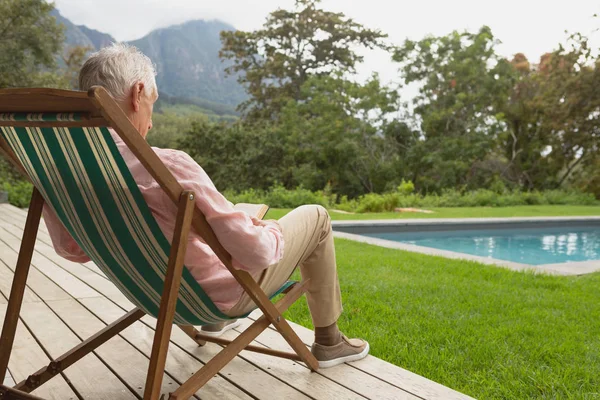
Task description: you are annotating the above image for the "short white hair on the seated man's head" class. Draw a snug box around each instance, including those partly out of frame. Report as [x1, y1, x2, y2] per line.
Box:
[79, 43, 158, 101]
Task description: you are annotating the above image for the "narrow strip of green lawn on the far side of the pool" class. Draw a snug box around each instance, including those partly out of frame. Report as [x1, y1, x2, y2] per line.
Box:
[266, 206, 600, 220]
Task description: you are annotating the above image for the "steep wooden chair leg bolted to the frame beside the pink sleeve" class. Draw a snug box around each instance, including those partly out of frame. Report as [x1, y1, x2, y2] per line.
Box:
[144, 191, 195, 400]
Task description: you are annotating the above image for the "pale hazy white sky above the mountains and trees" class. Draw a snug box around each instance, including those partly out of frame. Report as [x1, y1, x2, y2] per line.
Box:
[54, 0, 600, 84]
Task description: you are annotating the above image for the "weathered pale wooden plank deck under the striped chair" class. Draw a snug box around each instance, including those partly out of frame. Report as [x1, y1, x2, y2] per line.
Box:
[0, 204, 470, 400]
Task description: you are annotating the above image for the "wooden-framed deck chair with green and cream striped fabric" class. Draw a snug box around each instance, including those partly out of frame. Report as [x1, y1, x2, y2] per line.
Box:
[0, 87, 318, 400]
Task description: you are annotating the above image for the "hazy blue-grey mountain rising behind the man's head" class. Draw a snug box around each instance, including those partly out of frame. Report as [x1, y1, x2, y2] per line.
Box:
[52, 10, 247, 108]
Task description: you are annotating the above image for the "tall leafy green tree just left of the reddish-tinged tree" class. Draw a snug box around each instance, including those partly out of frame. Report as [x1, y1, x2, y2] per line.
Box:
[393, 27, 514, 192]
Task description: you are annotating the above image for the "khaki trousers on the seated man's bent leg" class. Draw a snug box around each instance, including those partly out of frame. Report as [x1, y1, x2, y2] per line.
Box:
[226, 205, 342, 327]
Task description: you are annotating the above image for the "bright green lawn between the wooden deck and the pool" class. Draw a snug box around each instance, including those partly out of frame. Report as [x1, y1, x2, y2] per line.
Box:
[288, 239, 600, 400]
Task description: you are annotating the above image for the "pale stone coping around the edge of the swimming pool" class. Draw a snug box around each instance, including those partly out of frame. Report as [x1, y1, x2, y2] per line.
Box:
[332, 216, 600, 275]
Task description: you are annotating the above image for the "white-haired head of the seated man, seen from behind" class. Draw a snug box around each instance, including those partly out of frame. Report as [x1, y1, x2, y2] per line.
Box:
[79, 43, 158, 138]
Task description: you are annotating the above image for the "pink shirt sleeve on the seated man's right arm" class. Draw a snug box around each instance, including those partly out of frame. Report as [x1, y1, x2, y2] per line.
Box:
[163, 151, 283, 272]
